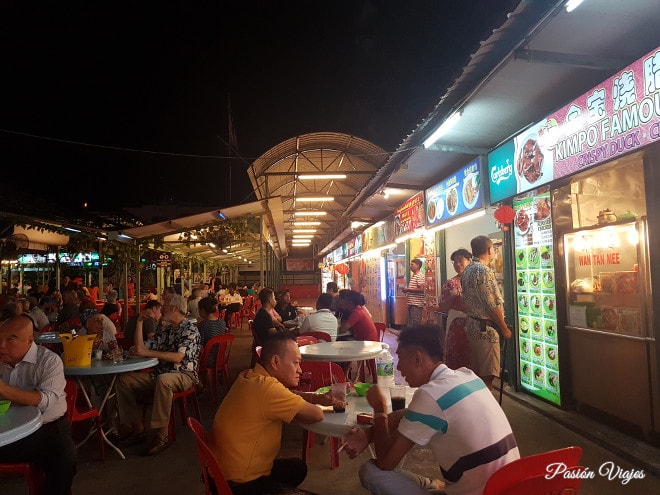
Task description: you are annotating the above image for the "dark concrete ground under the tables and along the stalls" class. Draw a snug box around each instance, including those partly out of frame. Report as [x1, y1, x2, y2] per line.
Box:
[0, 325, 660, 495]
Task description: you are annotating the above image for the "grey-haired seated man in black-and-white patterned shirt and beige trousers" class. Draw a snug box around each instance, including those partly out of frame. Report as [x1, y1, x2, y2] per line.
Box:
[117, 294, 201, 455]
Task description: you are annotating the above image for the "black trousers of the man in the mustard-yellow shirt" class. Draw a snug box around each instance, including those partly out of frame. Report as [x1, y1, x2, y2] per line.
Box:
[229, 457, 314, 495]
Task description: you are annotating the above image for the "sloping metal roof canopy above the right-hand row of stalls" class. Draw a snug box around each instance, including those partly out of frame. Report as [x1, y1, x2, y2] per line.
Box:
[319, 0, 660, 254]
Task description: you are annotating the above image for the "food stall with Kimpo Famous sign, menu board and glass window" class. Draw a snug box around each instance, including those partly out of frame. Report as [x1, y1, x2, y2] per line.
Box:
[488, 49, 660, 433]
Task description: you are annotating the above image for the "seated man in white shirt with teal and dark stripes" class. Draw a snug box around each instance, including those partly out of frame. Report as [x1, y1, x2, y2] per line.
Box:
[346, 325, 520, 495]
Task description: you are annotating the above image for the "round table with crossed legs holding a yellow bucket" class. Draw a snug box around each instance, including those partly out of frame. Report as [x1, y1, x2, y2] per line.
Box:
[64, 356, 158, 459]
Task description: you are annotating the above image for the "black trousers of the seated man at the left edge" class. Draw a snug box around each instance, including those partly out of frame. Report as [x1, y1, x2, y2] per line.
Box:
[0, 416, 78, 495]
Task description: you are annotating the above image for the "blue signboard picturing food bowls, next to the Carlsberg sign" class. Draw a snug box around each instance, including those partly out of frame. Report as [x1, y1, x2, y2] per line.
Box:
[424, 158, 483, 227]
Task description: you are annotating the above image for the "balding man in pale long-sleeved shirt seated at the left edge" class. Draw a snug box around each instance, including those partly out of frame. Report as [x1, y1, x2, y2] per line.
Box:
[0, 315, 77, 495]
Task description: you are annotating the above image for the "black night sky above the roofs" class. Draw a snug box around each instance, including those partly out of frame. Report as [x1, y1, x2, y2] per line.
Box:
[0, 0, 517, 210]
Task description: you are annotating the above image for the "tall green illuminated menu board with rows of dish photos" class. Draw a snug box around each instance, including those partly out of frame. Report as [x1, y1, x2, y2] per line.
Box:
[513, 191, 561, 405]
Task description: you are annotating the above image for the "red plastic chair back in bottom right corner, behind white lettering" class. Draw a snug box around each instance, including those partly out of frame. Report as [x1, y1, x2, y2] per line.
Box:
[483, 446, 584, 495]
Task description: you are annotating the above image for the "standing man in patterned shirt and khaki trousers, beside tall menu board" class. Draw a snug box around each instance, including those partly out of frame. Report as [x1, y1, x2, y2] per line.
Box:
[461, 235, 511, 389]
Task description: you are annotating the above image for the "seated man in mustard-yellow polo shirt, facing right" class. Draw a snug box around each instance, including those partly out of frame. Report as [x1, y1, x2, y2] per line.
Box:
[209, 334, 332, 495]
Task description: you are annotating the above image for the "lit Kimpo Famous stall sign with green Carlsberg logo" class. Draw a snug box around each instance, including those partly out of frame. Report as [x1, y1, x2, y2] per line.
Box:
[488, 48, 660, 202]
